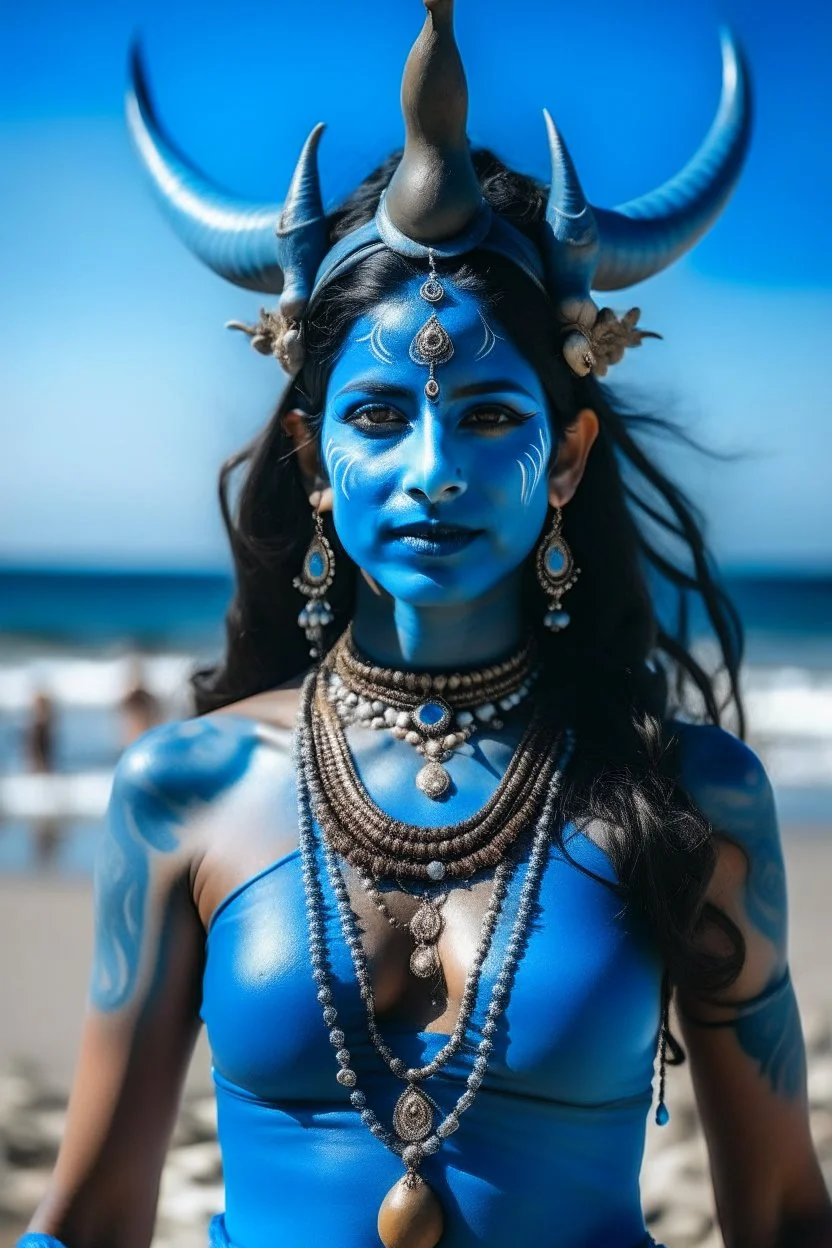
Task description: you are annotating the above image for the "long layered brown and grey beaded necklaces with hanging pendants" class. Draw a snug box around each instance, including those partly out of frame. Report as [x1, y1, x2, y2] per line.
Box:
[297, 669, 573, 1248]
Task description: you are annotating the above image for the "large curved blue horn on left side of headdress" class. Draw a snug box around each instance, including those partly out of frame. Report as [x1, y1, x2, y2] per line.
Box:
[127, 46, 283, 295]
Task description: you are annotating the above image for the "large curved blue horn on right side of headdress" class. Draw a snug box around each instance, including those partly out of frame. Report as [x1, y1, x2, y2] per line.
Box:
[591, 31, 752, 291]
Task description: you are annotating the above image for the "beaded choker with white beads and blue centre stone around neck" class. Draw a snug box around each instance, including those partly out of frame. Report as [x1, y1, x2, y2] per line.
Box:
[327, 626, 538, 799]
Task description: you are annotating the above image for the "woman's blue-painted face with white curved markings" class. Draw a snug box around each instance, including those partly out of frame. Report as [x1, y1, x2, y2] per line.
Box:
[322, 278, 553, 607]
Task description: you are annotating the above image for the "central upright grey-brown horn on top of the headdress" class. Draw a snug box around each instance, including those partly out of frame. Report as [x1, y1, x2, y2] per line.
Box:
[384, 0, 483, 245]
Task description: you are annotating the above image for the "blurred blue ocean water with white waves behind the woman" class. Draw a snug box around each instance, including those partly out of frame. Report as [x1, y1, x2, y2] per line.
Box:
[0, 569, 832, 874]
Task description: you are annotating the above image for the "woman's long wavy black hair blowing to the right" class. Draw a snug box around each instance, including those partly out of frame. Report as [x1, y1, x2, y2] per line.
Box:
[193, 150, 745, 991]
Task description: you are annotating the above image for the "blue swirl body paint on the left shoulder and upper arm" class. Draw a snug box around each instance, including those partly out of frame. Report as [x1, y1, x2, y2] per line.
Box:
[90, 720, 257, 1011]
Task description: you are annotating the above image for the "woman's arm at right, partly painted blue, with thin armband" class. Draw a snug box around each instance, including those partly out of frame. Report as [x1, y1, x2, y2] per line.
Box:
[677, 725, 832, 1248]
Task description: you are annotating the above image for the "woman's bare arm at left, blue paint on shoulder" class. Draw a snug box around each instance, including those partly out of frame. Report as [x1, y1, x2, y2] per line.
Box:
[29, 718, 257, 1248]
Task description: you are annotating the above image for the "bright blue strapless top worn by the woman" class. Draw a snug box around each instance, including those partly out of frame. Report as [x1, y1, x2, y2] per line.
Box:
[202, 832, 662, 1248]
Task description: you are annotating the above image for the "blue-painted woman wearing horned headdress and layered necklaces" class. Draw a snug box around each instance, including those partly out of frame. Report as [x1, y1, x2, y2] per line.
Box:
[21, 7, 832, 1248]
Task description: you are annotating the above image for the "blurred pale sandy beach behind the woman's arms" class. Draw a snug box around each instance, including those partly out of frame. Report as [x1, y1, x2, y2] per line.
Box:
[0, 826, 832, 1248]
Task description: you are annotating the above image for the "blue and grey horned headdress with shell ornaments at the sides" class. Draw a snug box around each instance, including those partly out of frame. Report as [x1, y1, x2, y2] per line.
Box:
[127, 0, 751, 376]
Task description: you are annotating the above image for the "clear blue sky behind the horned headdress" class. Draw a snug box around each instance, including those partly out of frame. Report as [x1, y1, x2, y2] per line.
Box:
[0, 0, 832, 569]
